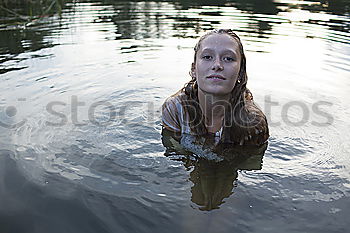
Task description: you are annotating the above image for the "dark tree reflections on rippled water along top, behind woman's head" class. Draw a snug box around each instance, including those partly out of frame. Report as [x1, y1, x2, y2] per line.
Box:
[88, 0, 349, 39]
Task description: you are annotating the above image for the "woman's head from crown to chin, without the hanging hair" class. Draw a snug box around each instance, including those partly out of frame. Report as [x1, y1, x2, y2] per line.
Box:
[190, 29, 247, 95]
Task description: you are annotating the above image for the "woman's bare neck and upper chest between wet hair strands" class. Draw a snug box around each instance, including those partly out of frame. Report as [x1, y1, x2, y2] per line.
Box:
[198, 89, 230, 132]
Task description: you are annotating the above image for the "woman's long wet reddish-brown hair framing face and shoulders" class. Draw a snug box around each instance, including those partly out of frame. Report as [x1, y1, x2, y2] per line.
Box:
[183, 29, 266, 143]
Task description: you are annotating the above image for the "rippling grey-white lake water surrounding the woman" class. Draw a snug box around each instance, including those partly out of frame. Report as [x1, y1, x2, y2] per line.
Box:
[0, 0, 350, 233]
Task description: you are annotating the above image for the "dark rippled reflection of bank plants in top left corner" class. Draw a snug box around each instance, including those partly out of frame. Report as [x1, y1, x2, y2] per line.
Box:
[0, 0, 70, 74]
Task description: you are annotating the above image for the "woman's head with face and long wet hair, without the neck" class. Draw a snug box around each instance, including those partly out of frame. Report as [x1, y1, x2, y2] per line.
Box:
[184, 29, 247, 142]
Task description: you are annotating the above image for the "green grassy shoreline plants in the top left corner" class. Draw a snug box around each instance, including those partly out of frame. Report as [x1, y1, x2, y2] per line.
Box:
[0, 0, 65, 30]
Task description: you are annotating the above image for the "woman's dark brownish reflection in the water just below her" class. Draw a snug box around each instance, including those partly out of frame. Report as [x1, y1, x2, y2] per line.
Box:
[162, 130, 267, 211]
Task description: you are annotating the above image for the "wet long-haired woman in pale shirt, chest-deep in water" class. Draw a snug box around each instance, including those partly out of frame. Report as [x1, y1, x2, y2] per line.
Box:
[162, 29, 269, 145]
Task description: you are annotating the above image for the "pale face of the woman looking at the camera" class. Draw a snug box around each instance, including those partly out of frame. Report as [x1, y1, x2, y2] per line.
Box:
[193, 34, 241, 95]
